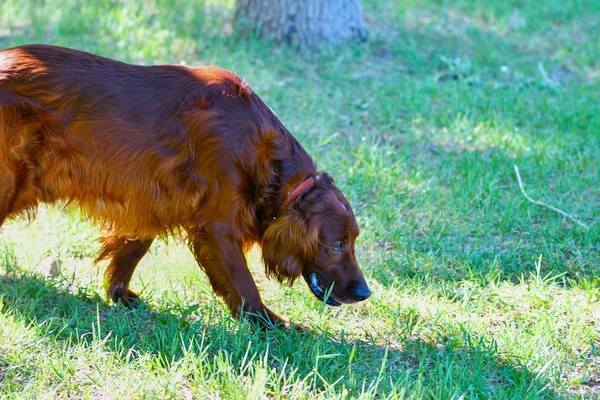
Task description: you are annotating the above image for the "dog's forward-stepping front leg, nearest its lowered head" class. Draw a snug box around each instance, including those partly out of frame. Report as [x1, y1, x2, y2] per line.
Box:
[188, 222, 285, 328]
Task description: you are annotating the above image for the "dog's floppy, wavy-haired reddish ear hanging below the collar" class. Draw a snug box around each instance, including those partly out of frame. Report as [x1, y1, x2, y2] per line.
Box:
[262, 210, 319, 284]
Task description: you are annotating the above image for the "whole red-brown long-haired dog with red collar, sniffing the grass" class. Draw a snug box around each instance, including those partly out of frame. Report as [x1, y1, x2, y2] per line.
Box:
[0, 45, 370, 326]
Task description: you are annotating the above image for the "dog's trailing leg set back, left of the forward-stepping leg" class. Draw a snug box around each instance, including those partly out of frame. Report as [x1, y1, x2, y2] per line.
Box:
[97, 236, 154, 307]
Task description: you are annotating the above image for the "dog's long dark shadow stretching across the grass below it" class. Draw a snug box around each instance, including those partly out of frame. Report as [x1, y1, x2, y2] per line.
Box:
[0, 272, 556, 398]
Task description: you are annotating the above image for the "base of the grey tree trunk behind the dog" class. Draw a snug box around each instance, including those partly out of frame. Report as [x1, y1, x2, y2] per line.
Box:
[234, 0, 367, 49]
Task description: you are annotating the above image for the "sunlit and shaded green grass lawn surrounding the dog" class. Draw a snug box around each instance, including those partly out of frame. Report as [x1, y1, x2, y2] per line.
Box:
[0, 0, 600, 399]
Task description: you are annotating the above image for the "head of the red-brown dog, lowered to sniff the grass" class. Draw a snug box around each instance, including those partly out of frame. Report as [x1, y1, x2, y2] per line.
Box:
[262, 173, 371, 306]
